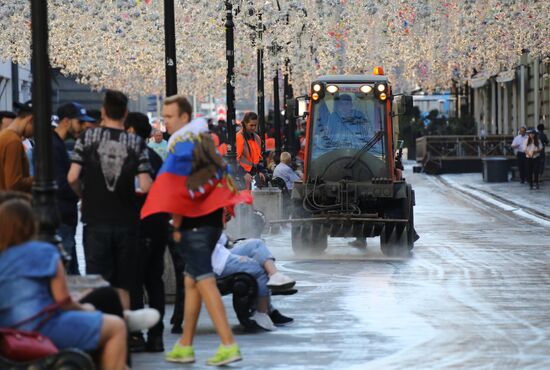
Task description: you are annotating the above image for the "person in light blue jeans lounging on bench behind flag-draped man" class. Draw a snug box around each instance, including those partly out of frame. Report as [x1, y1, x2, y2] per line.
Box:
[212, 233, 296, 331]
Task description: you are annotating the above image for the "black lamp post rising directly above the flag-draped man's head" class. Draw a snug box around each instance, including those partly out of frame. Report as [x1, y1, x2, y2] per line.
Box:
[164, 0, 178, 96]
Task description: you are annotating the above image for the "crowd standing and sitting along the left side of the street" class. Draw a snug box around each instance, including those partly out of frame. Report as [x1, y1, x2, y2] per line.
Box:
[0, 90, 300, 369]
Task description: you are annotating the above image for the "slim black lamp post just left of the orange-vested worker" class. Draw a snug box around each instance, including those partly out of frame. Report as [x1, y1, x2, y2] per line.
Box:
[225, 0, 236, 165]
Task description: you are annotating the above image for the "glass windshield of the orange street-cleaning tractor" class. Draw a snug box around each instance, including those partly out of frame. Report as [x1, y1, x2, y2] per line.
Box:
[310, 86, 386, 160]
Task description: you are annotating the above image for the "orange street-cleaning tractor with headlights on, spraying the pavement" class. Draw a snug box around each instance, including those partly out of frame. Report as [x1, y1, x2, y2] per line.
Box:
[290, 67, 418, 256]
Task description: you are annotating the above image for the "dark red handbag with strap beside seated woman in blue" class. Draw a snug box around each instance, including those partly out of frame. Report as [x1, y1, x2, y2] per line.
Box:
[0, 299, 68, 361]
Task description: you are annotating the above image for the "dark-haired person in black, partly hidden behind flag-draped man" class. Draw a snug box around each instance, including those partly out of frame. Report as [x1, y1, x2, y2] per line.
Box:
[124, 112, 168, 352]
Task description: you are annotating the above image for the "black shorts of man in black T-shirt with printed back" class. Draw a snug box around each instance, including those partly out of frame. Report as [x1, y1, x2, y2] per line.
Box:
[84, 225, 139, 290]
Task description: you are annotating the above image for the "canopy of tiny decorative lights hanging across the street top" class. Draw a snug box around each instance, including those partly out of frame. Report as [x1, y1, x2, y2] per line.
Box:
[0, 0, 550, 96]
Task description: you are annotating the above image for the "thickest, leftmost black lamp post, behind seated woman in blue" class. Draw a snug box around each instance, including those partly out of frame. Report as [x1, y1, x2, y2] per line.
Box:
[31, 0, 60, 244]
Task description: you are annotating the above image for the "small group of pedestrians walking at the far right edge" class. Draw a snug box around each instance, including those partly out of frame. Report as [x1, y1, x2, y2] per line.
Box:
[512, 124, 548, 190]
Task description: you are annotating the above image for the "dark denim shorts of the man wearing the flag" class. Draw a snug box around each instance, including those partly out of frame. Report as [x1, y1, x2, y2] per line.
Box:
[176, 226, 222, 281]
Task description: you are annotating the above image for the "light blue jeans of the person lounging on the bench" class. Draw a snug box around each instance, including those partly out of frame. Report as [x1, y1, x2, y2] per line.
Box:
[220, 239, 275, 297]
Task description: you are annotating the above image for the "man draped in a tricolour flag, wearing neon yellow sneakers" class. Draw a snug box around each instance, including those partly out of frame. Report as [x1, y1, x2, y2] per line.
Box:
[141, 95, 252, 366]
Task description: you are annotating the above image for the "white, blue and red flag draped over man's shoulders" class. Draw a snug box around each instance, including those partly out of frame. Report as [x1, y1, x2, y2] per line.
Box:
[141, 118, 252, 218]
